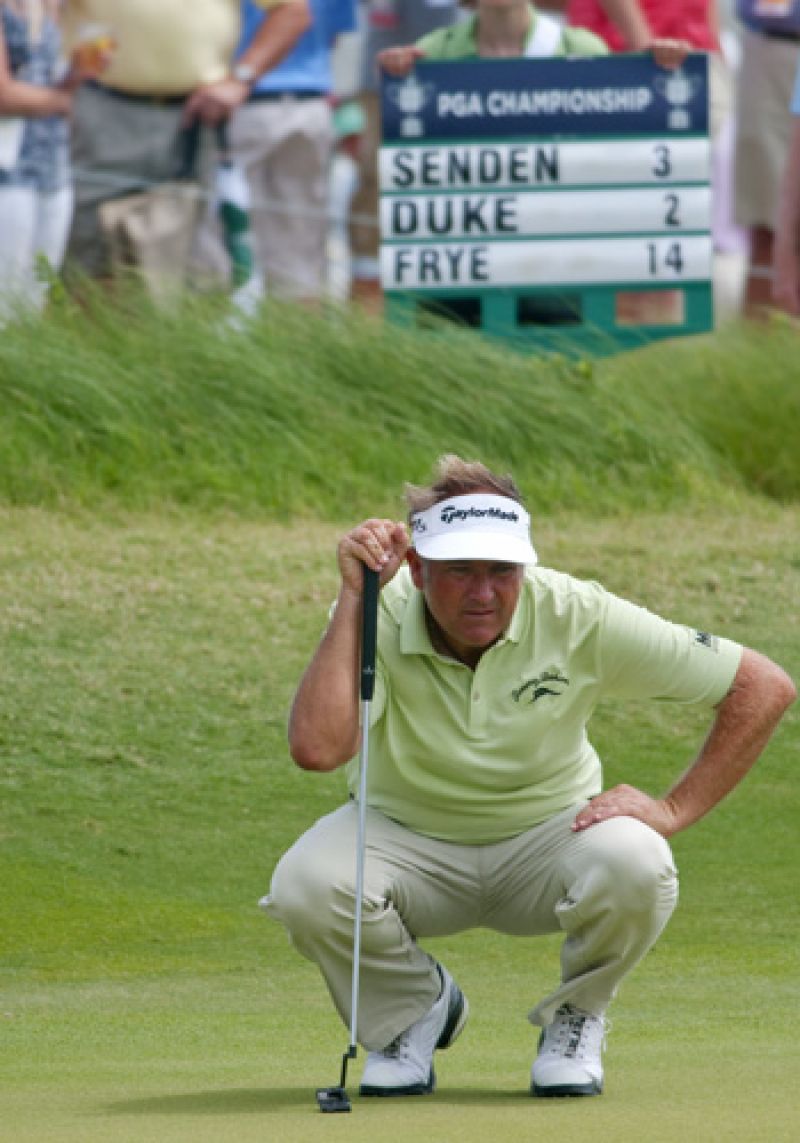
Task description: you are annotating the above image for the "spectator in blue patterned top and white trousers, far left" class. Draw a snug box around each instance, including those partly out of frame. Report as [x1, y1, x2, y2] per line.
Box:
[0, 0, 112, 322]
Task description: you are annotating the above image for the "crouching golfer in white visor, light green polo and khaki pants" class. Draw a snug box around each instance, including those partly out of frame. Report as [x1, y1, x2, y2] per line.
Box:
[263, 456, 795, 1096]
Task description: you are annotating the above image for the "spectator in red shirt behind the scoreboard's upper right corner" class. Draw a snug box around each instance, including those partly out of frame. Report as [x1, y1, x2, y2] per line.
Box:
[567, 0, 733, 137]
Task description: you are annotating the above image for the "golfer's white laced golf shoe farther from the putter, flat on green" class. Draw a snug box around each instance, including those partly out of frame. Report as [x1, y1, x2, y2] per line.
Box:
[530, 1004, 606, 1095]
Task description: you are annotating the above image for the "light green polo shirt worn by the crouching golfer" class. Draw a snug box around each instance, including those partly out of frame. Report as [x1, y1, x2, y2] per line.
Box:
[347, 567, 742, 845]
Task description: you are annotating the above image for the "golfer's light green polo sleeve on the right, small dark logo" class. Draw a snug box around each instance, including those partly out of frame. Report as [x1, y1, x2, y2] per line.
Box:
[598, 592, 742, 708]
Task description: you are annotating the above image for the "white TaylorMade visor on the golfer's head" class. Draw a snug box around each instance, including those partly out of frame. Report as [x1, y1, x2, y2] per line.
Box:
[411, 493, 537, 563]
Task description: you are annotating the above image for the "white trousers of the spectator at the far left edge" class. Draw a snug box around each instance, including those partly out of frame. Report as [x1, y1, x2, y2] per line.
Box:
[0, 186, 73, 321]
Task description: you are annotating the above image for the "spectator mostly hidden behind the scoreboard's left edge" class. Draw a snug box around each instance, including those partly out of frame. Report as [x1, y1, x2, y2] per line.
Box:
[350, 0, 459, 310]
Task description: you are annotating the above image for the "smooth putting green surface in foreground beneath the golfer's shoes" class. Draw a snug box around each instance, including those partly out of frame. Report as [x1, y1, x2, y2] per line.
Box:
[0, 955, 797, 1143]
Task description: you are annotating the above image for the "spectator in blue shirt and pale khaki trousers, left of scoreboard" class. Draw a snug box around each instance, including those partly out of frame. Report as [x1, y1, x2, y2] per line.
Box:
[198, 0, 355, 301]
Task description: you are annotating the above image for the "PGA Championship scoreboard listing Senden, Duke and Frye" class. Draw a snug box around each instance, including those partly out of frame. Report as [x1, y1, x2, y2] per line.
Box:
[378, 55, 713, 352]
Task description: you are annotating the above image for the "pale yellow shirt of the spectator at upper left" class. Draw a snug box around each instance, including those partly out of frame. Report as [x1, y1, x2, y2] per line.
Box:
[62, 0, 293, 96]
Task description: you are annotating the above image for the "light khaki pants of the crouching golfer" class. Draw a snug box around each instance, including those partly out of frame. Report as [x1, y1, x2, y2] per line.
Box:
[262, 802, 678, 1050]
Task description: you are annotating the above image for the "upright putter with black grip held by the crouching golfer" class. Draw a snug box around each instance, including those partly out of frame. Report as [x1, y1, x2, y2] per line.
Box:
[317, 563, 378, 1112]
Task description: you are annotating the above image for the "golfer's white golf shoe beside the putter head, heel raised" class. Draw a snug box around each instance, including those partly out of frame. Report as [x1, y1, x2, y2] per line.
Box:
[359, 965, 470, 1095]
